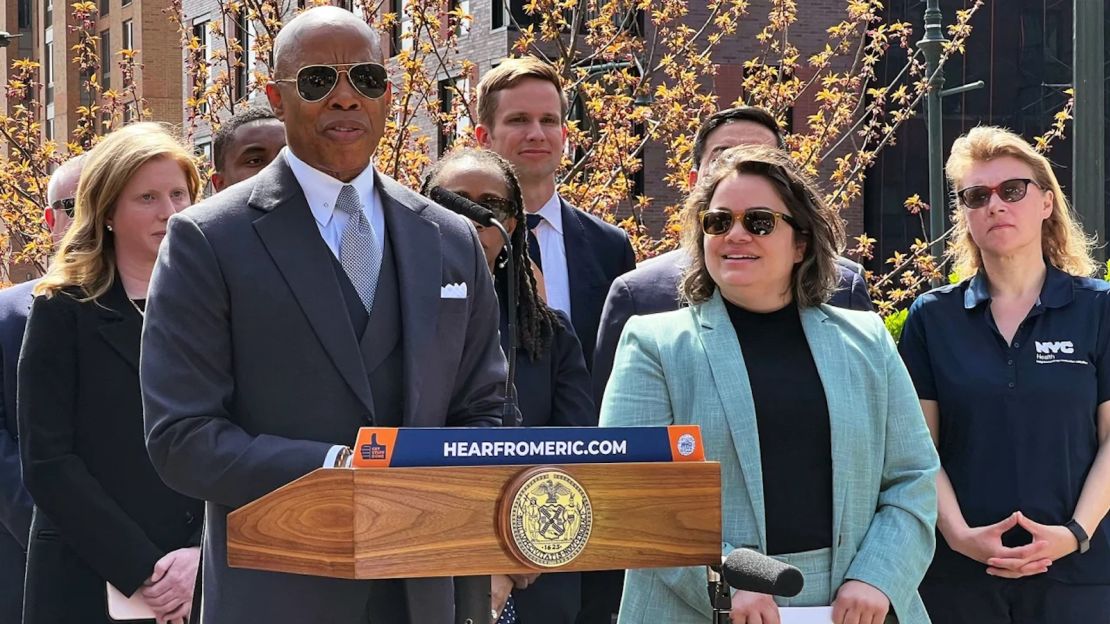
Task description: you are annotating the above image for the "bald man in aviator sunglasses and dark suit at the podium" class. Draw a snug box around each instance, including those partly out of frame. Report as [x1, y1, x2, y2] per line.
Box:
[141, 7, 506, 624]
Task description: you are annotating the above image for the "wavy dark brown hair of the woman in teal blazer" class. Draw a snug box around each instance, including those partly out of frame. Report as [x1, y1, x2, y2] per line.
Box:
[679, 141, 845, 308]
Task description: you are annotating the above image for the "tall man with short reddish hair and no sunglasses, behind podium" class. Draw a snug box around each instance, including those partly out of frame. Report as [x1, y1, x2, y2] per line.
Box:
[474, 57, 636, 366]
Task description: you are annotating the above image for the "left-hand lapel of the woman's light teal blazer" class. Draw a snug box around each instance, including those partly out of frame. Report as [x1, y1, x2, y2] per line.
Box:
[697, 291, 767, 552]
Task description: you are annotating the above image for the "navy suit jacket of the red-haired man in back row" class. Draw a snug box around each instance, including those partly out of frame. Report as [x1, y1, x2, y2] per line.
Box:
[561, 200, 636, 368]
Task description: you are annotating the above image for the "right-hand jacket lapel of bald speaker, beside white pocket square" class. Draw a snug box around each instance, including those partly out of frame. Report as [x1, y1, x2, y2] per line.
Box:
[376, 173, 444, 426]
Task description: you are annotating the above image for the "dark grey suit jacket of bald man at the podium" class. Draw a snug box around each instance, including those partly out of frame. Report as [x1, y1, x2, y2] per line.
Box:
[141, 158, 506, 624]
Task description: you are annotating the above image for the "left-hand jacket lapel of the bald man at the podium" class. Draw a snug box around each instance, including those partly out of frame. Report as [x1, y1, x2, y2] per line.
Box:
[248, 157, 374, 414]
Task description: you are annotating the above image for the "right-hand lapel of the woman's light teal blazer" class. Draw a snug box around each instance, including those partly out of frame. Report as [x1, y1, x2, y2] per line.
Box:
[801, 306, 852, 557]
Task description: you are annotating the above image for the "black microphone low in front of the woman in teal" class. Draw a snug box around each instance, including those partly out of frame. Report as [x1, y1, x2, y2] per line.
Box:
[707, 548, 806, 624]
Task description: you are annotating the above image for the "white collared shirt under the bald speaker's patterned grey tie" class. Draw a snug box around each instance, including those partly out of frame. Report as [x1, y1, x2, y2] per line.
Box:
[281, 145, 385, 259]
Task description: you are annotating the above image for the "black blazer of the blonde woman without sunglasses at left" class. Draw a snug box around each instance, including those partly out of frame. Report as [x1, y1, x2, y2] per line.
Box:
[18, 276, 203, 624]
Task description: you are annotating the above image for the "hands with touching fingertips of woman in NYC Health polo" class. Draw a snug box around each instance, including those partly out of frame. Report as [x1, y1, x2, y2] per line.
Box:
[946, 512, 1079, 578]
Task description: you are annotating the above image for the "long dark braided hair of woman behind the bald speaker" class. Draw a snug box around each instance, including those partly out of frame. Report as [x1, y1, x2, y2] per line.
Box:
[421, 148, 559, 362]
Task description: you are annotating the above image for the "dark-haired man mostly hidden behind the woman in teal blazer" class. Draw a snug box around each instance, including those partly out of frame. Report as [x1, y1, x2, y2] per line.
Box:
[593, 107, 872, 405]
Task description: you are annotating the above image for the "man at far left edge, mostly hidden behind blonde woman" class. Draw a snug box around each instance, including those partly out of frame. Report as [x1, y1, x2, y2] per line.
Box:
[0, 155, 83, 622]
